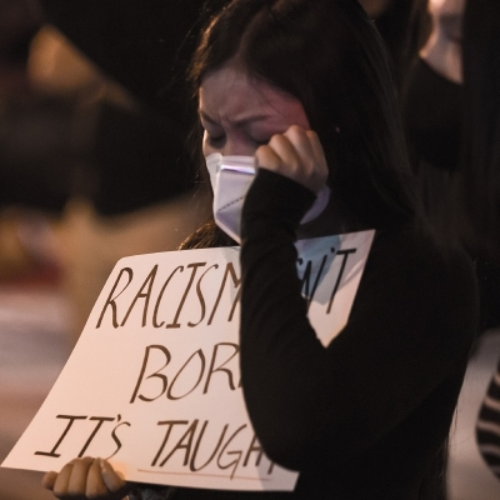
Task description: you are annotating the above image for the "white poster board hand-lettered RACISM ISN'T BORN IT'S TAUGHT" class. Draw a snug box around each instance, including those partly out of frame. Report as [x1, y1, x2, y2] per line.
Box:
[2, 231, 374, 491]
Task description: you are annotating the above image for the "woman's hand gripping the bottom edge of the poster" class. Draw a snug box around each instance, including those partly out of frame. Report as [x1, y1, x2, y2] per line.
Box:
[42, 457, 130, 500]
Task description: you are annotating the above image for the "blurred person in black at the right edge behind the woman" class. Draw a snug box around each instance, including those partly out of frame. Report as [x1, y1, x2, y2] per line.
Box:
[404, 0, 500, 484]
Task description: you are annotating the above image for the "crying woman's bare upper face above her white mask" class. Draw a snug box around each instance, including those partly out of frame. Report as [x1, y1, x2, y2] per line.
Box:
[199, 66, 310, 156]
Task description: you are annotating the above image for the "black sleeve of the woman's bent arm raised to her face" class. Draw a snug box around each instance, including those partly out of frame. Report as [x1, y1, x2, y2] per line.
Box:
[241, 171, 477, 470]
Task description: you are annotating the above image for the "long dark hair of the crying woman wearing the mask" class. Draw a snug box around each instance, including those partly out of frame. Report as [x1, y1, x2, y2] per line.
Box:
[183, 0, 416, 249]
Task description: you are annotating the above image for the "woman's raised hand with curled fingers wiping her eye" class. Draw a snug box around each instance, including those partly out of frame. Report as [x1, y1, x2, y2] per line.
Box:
[256, 125, 328, 194]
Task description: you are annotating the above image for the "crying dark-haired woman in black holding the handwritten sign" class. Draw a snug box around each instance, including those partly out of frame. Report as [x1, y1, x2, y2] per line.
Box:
[40, 0, 477, 500]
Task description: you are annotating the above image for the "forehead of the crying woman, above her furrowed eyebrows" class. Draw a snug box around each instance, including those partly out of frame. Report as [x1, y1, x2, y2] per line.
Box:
[199, 66, 305, 122]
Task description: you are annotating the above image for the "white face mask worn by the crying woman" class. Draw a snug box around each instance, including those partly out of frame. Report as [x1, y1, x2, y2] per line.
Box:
[206, 153, 330, 244]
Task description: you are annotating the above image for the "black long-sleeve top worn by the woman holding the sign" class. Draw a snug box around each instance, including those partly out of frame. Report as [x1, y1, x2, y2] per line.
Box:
[165, 171, 478, 500]
